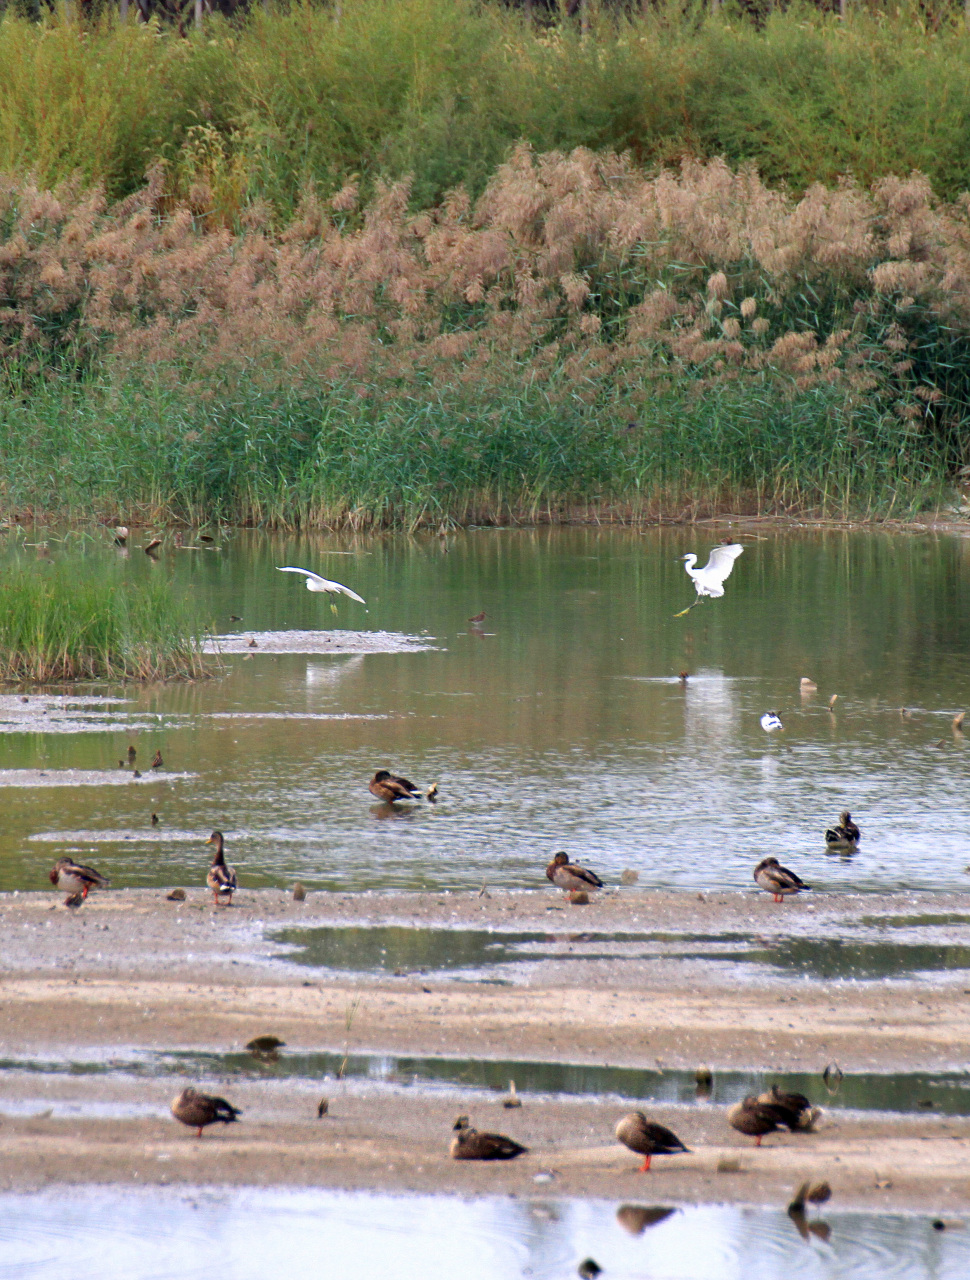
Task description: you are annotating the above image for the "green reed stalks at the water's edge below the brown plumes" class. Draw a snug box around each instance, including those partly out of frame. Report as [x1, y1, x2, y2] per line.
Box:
[0, 379, 947, 529]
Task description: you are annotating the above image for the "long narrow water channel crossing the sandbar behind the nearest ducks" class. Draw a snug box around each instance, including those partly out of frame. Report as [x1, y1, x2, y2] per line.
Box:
[0, 1048, 970, 1115]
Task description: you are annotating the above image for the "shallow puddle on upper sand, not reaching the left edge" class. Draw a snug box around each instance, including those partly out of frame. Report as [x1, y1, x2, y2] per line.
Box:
[269, 918, 970, 982]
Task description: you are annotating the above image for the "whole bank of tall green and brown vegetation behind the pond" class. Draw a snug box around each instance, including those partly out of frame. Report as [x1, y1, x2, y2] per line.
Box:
[0, 0, 970, 527]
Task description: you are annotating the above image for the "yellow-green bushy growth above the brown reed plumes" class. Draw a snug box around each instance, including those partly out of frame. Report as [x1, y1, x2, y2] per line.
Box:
[0, 0, 970, 209]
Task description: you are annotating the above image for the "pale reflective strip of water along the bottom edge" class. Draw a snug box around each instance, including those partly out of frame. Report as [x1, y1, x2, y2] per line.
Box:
[0, 1187, 970, 1280]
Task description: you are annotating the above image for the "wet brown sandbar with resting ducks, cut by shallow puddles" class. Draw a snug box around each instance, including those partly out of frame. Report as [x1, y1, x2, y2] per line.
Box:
[0, 888, 970, 1213]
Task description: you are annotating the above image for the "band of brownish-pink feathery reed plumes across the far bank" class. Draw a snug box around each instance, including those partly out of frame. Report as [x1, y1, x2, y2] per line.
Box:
[0, 145, 970, 440]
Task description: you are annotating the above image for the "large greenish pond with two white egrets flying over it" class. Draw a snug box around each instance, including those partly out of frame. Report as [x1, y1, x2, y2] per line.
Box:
[0, 529, 970, 892]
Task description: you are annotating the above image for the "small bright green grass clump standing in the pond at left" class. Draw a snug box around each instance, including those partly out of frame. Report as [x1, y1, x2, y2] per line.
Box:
[0, 563, 211, 684]
